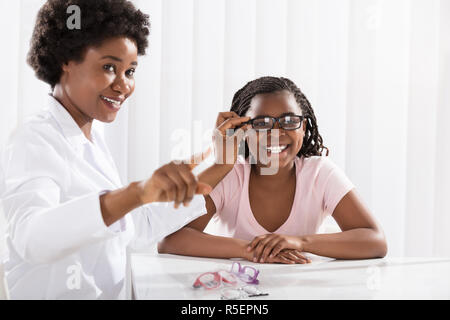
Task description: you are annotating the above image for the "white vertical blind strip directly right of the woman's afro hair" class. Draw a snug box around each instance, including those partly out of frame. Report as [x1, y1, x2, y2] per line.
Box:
[122, 0, 163, 181]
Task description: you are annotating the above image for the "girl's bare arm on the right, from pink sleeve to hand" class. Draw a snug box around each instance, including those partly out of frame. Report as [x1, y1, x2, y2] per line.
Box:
[248, 190, 387, 262]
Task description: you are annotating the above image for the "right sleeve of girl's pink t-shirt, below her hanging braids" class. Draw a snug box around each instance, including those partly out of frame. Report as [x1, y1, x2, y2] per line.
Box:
[321, 158, 355, 216]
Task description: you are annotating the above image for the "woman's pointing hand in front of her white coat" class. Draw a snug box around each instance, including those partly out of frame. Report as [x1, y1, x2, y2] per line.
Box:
[138, 157, 212, 208]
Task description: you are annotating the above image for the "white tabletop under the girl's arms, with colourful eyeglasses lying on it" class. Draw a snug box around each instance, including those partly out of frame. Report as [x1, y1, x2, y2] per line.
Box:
[131, 253, 450, 300]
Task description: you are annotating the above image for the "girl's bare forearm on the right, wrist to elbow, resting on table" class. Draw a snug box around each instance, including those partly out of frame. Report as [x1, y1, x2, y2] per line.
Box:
[302, 228, 387, 259]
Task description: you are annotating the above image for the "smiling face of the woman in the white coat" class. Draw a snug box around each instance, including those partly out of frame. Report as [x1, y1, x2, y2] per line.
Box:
[60, 37, 138, 122]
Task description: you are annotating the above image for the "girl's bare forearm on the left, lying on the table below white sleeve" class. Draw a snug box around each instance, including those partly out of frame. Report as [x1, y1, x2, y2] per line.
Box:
[158, 227, 249, 258]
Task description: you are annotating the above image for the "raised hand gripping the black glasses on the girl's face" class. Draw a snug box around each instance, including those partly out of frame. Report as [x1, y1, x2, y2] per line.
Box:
[213, 111, 250, 165]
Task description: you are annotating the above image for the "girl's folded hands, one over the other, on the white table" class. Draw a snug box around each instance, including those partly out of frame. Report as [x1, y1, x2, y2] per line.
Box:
[247, 234, 310, 263]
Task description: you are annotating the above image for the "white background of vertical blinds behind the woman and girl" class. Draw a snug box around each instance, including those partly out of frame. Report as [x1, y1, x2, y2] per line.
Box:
[0, 0, 450, 256]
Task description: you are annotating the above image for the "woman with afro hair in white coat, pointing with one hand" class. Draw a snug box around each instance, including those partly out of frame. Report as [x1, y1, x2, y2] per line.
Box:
[0, 0, 221, 299]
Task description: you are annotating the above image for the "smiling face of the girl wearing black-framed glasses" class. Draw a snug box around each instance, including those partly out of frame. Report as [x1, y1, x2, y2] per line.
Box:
[246, 90, 306, 168]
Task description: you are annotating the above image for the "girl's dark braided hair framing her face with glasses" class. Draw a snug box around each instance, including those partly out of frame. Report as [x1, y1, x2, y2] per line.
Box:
[231, 77, 329, 158]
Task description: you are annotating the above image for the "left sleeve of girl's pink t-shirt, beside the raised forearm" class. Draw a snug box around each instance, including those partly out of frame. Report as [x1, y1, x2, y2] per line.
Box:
[209, 164, 242, 213]
